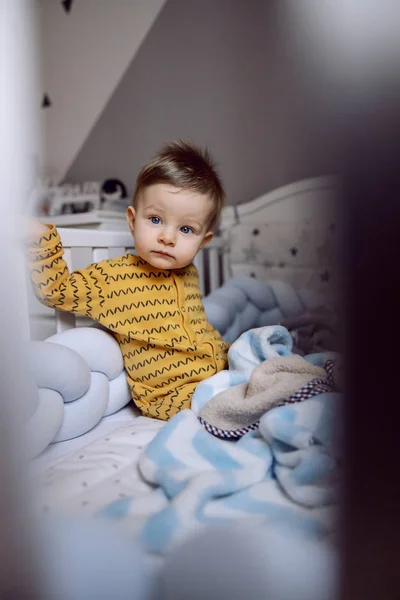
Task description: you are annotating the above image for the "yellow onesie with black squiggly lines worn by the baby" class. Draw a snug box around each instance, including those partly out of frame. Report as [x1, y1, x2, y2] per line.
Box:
[29, 227, 229, 421]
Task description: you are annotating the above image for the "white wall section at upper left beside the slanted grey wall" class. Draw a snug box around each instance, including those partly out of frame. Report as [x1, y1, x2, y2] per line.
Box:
[39, 0, 166, 180]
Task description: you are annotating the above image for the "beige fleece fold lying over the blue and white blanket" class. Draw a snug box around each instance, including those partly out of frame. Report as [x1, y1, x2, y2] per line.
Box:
[199, 355, 327, 431]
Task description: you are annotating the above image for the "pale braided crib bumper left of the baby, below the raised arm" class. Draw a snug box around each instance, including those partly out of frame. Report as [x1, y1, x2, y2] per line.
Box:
[26, 327, 131, 457]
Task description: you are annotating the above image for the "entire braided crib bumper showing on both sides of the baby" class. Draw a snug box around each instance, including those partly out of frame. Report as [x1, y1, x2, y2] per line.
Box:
[25, 277, 321, 457]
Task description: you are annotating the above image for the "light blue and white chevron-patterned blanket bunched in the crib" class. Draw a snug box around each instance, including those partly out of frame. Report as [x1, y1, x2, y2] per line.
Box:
[98, 326, 340, 553]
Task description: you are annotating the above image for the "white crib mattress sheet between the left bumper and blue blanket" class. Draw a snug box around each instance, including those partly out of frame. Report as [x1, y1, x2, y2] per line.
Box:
[32, 411, 165, 515]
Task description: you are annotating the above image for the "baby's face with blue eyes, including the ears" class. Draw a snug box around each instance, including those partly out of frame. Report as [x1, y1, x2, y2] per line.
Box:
[126, 183, 212, 269]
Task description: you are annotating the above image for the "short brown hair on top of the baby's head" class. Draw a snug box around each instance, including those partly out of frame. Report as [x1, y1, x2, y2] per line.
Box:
[133, 140, 225, 229]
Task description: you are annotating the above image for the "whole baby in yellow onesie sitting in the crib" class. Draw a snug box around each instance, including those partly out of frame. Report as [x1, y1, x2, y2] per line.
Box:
[29, 141, 228, 420]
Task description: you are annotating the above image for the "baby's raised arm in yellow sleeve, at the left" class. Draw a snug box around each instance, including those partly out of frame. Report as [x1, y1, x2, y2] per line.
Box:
[28, 221, 108, 319]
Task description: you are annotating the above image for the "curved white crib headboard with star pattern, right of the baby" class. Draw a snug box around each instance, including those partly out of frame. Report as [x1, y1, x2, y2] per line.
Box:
[216, 176, 339, 301]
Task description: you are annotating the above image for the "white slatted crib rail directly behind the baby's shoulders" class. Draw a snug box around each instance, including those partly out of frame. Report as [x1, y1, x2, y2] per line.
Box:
[50, 227, 227, 333]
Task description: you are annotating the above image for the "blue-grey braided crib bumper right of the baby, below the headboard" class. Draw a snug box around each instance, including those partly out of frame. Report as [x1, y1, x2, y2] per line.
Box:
[203, 277, 323, 343]
